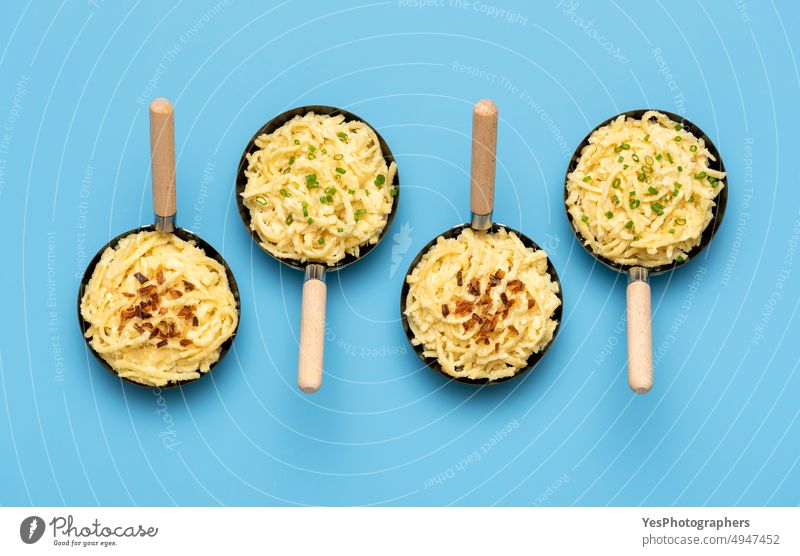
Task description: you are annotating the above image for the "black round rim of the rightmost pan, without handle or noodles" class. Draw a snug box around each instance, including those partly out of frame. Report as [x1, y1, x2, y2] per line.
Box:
[563, 108, 730, 275]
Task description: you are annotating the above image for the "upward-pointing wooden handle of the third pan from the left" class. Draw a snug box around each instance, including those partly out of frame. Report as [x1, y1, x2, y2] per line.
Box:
[469, 99, 497, 215]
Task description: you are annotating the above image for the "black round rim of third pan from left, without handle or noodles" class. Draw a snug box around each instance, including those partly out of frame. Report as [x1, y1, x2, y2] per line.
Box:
[400, 222, 564, 386]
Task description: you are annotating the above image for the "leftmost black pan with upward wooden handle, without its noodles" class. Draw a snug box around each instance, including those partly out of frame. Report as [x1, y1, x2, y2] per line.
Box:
[78, 98, 241, 388]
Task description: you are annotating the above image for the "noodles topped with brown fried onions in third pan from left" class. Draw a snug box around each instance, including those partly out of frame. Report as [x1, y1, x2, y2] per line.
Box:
[405, 228, 561, 380]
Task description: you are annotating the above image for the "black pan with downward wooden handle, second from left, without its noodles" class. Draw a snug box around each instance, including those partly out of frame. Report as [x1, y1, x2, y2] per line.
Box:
[236, 106, 400, 394]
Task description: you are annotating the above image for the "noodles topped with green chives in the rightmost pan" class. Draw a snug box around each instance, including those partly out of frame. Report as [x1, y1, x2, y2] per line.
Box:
[566, 111, 725, 267]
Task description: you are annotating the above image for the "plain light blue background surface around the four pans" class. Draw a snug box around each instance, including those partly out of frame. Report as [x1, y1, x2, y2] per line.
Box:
[0, 0, 800, 505]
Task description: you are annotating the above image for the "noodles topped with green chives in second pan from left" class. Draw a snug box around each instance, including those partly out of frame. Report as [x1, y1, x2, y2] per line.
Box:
[242, 112, 397, 265]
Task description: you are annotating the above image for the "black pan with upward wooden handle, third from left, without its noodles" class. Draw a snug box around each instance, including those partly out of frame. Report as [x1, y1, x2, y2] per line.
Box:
[400, 100, 564, 385]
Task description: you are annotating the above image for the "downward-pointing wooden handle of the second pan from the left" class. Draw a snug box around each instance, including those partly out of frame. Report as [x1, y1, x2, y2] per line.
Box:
[297, 278, 327, 394]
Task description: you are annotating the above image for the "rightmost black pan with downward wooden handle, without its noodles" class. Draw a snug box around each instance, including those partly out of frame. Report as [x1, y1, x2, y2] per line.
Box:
[564, 109, 729, 394]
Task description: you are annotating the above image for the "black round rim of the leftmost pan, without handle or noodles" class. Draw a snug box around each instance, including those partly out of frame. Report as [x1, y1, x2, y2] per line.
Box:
[77, 224, 242, 390]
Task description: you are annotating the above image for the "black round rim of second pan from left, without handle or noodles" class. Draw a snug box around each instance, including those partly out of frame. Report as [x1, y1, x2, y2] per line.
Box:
[234, 104, 401, 272]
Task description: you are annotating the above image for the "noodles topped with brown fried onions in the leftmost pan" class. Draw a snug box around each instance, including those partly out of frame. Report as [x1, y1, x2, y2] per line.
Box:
[81, 232, 239, 386]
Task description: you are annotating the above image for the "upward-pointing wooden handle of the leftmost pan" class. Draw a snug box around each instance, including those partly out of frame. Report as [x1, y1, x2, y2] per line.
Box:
[150, 98, 176, 217]
